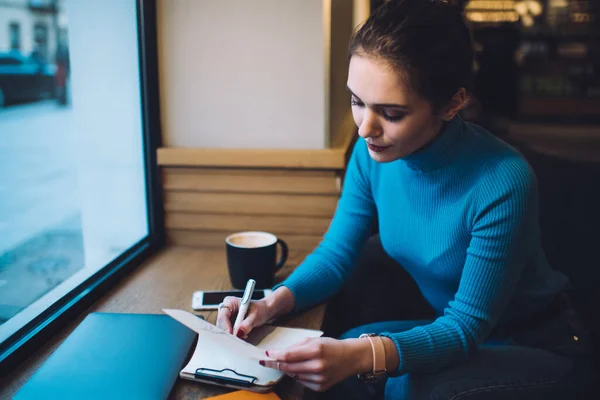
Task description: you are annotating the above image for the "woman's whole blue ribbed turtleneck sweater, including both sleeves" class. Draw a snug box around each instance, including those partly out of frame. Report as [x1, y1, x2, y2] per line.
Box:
[278, 118, 567, 375]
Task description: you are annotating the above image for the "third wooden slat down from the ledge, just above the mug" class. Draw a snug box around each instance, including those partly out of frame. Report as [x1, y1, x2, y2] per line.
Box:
[165, 212, 331, 235]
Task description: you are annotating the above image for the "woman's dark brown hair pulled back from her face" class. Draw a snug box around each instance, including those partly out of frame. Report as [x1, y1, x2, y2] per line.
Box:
[349, 0, 474, 111]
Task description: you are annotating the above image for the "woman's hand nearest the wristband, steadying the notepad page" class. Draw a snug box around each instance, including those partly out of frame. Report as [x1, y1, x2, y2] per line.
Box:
[260, 338, 373, 392]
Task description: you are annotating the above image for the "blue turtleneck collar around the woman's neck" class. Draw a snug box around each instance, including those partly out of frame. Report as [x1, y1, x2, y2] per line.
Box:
[399, 117, 464, 172]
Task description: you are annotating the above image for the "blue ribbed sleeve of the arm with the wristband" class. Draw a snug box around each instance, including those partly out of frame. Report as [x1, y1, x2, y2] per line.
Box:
[382, 154, 537, 375]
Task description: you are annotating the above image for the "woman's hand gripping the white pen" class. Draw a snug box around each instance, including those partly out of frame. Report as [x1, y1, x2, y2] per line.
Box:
[217, 286, 295, 338]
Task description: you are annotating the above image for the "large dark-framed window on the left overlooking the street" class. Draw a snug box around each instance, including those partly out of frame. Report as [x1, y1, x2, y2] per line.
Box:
[0, 0, 162, 368]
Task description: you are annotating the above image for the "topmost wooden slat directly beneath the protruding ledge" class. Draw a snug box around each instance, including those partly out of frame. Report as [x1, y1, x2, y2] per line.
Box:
[162, 168, 341, 195]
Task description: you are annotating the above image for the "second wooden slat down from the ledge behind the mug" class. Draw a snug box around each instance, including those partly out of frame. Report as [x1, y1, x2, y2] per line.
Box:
[165, 191, 338, 218]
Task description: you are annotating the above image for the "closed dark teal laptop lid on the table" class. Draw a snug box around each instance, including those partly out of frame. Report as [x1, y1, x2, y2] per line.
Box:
[15, 313, 196, 400]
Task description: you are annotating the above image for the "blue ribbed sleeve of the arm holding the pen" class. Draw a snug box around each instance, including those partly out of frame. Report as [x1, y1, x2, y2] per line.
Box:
[274, 139, 375, 310]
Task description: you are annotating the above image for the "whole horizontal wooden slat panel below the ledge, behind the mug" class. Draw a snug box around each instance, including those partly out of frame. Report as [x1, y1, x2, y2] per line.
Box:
[162, 167, 342, 251]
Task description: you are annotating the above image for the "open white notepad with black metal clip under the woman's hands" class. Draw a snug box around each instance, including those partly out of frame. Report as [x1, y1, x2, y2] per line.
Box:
[163, 309, 323, 392]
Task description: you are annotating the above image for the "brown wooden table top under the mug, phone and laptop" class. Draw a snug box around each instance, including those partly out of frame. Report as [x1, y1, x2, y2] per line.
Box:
[0, 247, 325, 399]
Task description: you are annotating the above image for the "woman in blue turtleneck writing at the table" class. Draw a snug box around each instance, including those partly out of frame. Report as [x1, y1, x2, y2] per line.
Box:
[217, 0, 583, 399]
